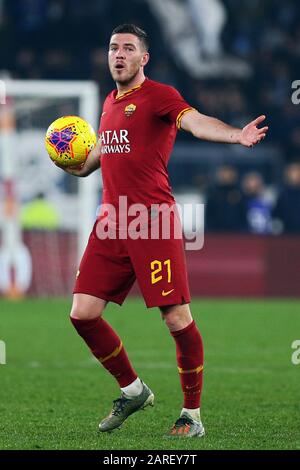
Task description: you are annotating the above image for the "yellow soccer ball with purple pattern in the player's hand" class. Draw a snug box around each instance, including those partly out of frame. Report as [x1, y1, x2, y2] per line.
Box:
[45, 116, 97, 167]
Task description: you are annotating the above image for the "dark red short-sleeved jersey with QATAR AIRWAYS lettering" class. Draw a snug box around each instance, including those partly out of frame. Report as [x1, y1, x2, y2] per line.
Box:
[99, 78, 193, 207]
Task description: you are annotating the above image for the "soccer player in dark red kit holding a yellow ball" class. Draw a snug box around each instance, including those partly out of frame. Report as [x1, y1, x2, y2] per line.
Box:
[57, 24, 268, 438]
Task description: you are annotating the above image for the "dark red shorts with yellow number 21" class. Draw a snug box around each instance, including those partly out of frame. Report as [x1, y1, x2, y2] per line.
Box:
[73, 210, 190, 307]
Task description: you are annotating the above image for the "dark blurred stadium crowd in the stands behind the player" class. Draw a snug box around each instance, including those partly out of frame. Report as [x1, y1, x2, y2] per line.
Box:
[0, 0, 300, 233]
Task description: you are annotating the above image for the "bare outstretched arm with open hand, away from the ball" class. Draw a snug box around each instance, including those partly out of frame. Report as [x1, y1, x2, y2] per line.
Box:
[181, 110, 268, 147]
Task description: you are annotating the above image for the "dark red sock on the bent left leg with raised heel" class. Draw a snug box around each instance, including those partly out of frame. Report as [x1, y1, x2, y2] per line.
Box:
[70, 317, 137, 387]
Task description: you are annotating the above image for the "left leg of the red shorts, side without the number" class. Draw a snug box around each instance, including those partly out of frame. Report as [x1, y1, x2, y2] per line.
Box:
[73, 224, 135, 305]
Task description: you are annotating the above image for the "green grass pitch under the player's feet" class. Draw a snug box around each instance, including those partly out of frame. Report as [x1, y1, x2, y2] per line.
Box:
[0, 299, 300, 451]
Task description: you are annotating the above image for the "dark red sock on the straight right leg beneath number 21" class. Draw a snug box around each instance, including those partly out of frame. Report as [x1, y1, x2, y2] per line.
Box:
[171, 321, 203, 409]
